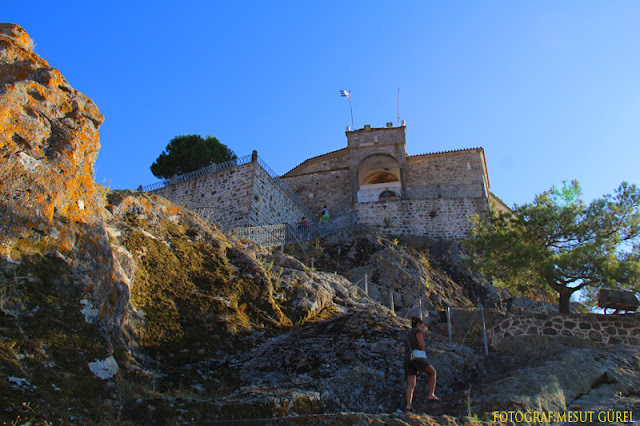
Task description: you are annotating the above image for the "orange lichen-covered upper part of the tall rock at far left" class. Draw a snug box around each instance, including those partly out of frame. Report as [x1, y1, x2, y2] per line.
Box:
[0, 24, 104, 256]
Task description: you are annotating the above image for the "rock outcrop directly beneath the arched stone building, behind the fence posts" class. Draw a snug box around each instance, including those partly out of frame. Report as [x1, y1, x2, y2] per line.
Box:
[307, 233, 509, 324]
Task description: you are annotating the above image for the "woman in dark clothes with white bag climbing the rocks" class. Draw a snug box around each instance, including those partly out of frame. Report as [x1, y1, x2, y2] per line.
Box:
[402, 317, 440, 411]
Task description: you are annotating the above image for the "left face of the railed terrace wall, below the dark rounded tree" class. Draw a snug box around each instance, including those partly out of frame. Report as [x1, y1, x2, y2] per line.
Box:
[152, 163, 257, 230]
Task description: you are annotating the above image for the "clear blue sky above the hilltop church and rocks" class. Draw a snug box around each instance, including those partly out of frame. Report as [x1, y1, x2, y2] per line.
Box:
[5, 0, 640, 205]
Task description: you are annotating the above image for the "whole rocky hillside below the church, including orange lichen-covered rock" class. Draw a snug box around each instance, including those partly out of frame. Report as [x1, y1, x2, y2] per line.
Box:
[0, 24, 640, 425]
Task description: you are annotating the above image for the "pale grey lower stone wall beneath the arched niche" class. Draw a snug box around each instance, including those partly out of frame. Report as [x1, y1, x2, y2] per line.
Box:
[356, 198, 488, 239]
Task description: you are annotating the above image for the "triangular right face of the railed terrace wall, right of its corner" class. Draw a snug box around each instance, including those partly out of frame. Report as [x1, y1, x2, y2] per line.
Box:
[249, 166, 306, 225]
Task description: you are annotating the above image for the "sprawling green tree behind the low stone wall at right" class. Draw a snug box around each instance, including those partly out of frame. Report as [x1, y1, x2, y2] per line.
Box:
[464, 180, 640, 313]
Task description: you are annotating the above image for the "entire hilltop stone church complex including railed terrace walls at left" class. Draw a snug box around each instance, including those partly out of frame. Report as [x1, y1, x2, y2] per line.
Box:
[146, 122, 505, 239]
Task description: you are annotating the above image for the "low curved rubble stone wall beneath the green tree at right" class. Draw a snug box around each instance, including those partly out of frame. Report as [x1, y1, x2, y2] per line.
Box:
[487, 314, 640, 346]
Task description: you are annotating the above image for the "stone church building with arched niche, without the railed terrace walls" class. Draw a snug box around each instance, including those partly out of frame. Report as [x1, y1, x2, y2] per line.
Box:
[282, 123, 492, 239]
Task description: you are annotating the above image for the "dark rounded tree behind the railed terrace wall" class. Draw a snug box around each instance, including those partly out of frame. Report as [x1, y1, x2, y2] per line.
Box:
[151, 135, 238, 179]
